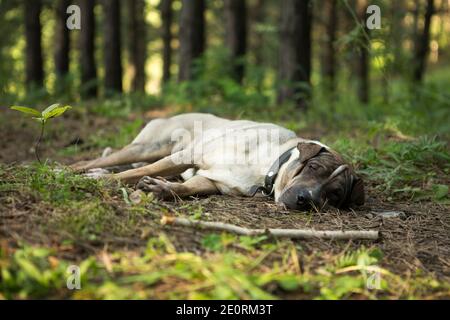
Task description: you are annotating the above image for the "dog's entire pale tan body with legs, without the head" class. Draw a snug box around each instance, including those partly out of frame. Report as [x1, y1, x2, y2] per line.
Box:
[72, 113, 364, 210]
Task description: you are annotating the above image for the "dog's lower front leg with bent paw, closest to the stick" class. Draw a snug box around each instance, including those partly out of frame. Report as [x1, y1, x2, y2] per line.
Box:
[137, 176, 219, 200]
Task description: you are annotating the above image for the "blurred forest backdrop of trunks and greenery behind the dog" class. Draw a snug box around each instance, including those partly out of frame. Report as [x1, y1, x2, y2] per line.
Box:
[0, 0, 450, 135]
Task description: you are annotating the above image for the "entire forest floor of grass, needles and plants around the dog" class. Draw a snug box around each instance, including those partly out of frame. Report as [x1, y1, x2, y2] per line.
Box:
[0, 111, 450, 299]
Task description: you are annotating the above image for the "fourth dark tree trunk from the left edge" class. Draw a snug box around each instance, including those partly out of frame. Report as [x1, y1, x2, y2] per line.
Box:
[103, 0, 122, 94]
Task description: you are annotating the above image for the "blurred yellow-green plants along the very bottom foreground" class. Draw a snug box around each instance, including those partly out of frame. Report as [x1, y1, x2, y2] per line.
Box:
[0, 240, 450, 299]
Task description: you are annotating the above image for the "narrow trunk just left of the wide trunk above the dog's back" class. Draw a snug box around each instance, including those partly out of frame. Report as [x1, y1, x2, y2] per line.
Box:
[161, 0, 173, 82]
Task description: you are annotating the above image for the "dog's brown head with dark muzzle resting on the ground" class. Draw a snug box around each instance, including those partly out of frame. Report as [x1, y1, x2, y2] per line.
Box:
[275, 142, 364, 209]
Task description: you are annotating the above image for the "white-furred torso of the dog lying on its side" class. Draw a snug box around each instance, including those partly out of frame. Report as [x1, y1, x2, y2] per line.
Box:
[81, 113, 334, 200]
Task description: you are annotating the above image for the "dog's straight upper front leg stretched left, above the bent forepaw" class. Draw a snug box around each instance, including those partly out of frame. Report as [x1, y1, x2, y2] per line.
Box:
[113, 151, 195, 184]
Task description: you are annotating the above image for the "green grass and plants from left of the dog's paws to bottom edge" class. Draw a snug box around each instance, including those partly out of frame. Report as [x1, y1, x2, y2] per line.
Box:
[0, 165, 450, 299]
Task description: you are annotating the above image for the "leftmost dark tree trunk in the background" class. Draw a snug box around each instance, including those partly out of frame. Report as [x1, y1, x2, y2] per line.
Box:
[24, 0, 44, 88]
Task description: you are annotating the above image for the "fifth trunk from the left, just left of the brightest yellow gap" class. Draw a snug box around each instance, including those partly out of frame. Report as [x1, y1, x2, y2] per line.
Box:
[127, 0, 147, 92]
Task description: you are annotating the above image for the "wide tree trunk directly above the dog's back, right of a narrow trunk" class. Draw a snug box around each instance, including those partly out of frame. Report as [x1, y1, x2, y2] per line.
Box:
[178, 0, 205, 81]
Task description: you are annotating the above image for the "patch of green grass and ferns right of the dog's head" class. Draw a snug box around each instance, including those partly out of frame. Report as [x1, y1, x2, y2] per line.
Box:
[331, 136, 450, 204]
